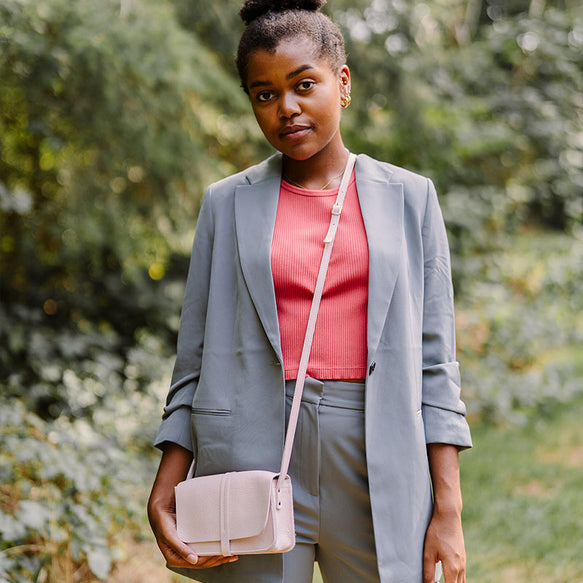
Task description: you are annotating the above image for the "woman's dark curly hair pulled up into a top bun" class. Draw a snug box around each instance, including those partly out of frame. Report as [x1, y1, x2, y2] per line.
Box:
[236, 0, 346, 92]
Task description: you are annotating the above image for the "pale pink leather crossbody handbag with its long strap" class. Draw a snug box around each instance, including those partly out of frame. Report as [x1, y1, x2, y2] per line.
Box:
[175, 154, 356, 556]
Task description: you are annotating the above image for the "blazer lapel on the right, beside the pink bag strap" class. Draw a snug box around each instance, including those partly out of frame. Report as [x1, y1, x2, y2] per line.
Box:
[356, 155, 404, 360]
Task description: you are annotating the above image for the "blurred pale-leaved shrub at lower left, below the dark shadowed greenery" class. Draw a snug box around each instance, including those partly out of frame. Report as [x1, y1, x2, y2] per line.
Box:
[0, 308, 170, 583]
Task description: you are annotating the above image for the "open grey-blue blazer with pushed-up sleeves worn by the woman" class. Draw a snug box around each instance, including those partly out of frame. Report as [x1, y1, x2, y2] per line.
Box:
[156, 154, 471, 583]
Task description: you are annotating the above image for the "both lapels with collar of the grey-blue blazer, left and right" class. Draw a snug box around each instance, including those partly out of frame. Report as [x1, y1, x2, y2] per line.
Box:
[235, 153, 404, 360]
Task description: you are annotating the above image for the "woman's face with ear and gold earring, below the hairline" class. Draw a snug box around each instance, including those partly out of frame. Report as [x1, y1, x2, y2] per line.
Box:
[247, 37, 350, 160]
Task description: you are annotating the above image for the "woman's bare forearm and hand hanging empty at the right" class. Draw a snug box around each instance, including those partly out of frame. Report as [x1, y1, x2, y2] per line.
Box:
[423, 443, 466, 583]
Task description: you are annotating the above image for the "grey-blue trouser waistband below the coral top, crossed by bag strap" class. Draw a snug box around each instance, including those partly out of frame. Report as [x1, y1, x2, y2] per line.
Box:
[285, 377, 364, 411]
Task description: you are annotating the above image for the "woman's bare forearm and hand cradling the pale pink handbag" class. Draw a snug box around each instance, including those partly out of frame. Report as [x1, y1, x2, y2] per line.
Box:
[148, 443, 237, 569]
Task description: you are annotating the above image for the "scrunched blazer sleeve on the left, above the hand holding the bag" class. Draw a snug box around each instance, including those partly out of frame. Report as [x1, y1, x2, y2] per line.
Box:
[154, 187, 214, 451]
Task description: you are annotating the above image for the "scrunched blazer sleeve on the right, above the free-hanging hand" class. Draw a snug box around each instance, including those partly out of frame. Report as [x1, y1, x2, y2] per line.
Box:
[422, 180, 472, 449]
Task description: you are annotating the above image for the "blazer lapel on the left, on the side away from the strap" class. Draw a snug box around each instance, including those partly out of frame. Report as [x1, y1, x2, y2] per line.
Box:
[235, 154, 282, 361]
